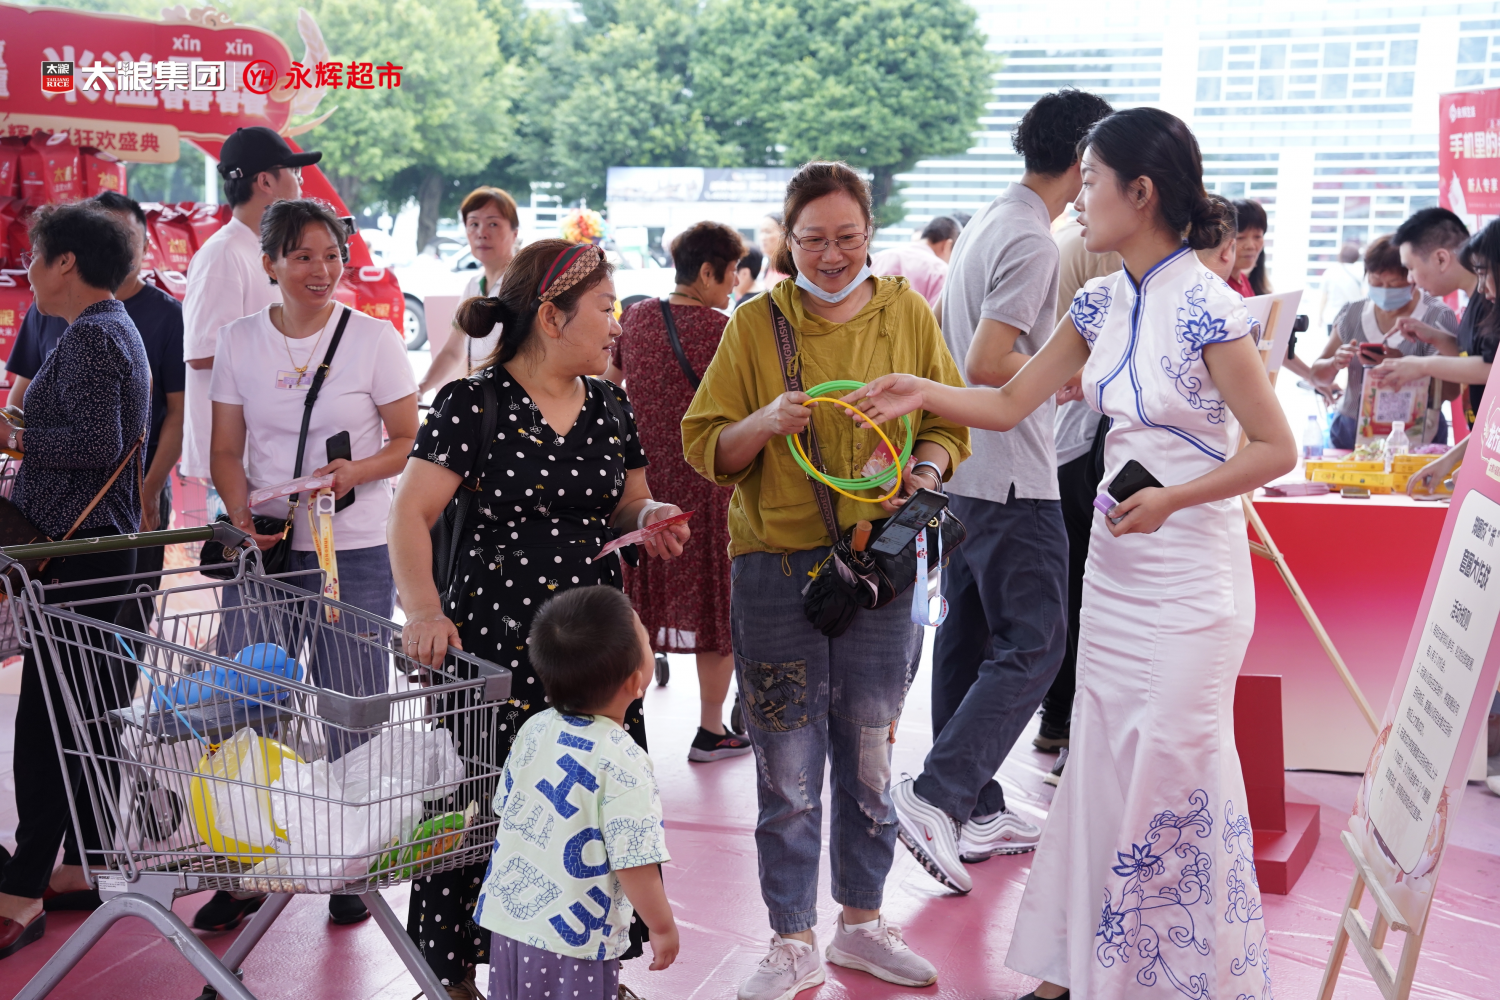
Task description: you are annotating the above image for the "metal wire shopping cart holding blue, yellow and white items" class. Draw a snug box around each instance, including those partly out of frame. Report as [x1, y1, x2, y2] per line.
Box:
[0, 523, 510, 1000]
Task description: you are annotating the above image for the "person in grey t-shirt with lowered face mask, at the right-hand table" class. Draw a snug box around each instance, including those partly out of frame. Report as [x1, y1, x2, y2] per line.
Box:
[1310, 235, 1458, 448]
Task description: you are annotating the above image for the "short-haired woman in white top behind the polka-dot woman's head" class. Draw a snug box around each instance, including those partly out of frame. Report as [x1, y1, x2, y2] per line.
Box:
[417, 187, 521, 396]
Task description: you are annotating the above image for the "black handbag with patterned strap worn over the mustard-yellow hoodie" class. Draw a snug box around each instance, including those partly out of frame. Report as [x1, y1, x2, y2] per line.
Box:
[765, 295, 968, 639]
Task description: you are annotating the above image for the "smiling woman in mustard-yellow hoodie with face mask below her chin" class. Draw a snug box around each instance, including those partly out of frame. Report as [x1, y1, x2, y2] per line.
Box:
[683, 162, 969, 1000]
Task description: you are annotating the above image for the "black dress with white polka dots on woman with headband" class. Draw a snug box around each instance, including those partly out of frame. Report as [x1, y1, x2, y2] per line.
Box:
[407, 367, 647, 984]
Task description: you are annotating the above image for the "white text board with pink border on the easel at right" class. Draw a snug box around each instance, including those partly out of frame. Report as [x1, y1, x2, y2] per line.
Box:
[1349, 358, 1500, 933]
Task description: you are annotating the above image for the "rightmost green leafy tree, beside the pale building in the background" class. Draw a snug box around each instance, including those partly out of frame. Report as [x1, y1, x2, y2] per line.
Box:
[690, 0, 999, 223]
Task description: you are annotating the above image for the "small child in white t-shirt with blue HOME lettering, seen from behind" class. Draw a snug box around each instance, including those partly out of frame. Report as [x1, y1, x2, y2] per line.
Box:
[474, 586, 678, 1000]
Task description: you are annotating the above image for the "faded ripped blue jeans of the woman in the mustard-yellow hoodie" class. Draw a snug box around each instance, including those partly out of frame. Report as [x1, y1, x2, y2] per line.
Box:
[729, 549, 923, 934]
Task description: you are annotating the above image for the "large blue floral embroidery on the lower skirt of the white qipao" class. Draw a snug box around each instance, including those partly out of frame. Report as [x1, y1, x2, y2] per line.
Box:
[1094, 789, 1214, 1000]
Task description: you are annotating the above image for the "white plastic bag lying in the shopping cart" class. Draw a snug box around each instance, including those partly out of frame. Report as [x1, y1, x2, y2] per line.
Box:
[251, 729, 465, 892]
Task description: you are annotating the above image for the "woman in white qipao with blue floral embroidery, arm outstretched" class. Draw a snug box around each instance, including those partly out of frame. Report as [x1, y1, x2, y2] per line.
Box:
[848, 108, 1296, 1000]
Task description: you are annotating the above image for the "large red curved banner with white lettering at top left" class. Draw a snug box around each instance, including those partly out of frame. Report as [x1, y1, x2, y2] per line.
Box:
[0, 3, 296, 150]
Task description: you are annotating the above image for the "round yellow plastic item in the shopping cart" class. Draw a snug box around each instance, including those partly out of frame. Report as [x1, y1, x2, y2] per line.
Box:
[189, 729, 303, 862]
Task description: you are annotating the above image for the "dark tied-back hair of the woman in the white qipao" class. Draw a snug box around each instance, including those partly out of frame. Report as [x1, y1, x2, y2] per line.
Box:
[1079, 108, 1233, 250]
